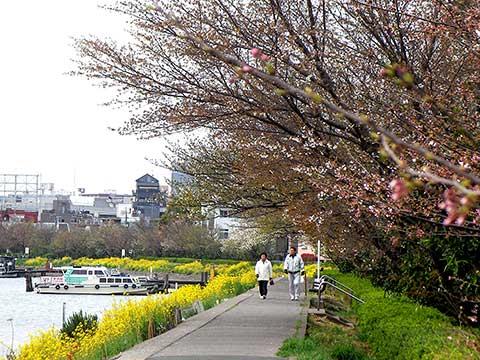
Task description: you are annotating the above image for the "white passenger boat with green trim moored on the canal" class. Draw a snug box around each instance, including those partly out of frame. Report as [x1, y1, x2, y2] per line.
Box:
[35, 266, 148, 295]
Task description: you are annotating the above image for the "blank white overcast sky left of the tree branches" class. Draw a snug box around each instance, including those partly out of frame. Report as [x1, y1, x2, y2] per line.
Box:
[0, 0, 169, 192]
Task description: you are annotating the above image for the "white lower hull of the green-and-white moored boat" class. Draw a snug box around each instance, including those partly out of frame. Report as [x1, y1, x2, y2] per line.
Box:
[36, 284, 148, 295]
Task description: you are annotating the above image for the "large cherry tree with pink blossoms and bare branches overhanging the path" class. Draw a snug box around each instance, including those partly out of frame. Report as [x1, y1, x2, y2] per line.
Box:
[73, 0, 480, 322]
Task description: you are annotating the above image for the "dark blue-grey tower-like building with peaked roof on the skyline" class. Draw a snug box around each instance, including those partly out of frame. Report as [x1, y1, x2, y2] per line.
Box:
[133, 174, 167, 222]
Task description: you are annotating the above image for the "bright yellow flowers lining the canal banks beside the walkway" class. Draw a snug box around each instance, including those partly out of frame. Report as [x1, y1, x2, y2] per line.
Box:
[19, 258, 256, 360]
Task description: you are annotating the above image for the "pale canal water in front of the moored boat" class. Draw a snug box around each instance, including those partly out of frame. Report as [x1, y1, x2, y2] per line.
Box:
[0, 278, 138, 357]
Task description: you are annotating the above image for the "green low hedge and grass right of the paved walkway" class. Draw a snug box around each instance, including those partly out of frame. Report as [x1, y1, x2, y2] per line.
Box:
[279, 270, 480, 360]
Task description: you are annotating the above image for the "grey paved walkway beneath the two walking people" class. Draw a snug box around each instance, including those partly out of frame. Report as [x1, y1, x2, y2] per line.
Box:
[115, 279, 306, 360]
